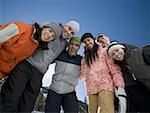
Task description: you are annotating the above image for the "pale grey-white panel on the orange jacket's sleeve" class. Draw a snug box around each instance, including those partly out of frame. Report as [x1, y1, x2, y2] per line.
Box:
[0, 23, 19, 43]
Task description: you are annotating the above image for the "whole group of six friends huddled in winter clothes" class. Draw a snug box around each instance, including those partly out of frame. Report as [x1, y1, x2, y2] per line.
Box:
[0, 21, 150, 113]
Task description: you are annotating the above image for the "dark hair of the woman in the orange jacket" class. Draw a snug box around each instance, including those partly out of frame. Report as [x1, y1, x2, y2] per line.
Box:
[33, 23, 48, 50]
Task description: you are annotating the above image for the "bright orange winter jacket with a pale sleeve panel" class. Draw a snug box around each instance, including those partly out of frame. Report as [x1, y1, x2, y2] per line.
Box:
[0, 22, 38, 79]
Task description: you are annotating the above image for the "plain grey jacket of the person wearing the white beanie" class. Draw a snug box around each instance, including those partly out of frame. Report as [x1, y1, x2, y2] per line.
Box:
[27, 23, 67, 74]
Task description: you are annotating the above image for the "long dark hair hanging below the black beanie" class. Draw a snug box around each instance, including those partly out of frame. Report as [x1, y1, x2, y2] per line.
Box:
[84, 41, 98, 66]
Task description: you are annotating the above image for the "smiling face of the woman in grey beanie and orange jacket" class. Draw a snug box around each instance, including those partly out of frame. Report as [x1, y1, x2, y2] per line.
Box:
[41, 28, 55, 42]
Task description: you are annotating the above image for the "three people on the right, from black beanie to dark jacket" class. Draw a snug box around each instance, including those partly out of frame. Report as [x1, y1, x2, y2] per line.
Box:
[80, 33, 150, 113]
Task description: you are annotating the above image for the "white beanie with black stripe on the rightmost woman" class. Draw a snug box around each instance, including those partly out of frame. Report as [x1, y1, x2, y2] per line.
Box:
[107, 41, 125, 56]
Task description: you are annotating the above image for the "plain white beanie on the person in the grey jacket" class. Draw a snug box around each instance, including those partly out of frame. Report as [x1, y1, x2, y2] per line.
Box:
[65, 20, 80, 34]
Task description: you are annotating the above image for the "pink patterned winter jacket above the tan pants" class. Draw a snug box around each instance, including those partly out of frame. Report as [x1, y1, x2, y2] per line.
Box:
[80, 46, 125, 95]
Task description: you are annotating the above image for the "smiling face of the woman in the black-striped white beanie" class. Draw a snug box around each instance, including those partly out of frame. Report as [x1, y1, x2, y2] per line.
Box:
[111, 48, 125, 61]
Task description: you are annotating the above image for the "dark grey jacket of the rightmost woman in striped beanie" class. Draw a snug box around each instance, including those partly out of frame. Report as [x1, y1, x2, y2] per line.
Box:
[125, 45, 150, 90]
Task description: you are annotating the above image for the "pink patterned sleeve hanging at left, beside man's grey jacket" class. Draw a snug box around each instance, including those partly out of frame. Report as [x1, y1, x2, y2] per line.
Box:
[80, 58, 87, 80]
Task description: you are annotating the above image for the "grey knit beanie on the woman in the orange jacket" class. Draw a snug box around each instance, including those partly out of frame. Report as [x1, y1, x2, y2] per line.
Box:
[40, 22, 63, 38]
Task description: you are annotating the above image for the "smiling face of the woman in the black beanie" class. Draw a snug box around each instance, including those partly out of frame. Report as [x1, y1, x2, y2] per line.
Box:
[83, 37, 94, 49]
